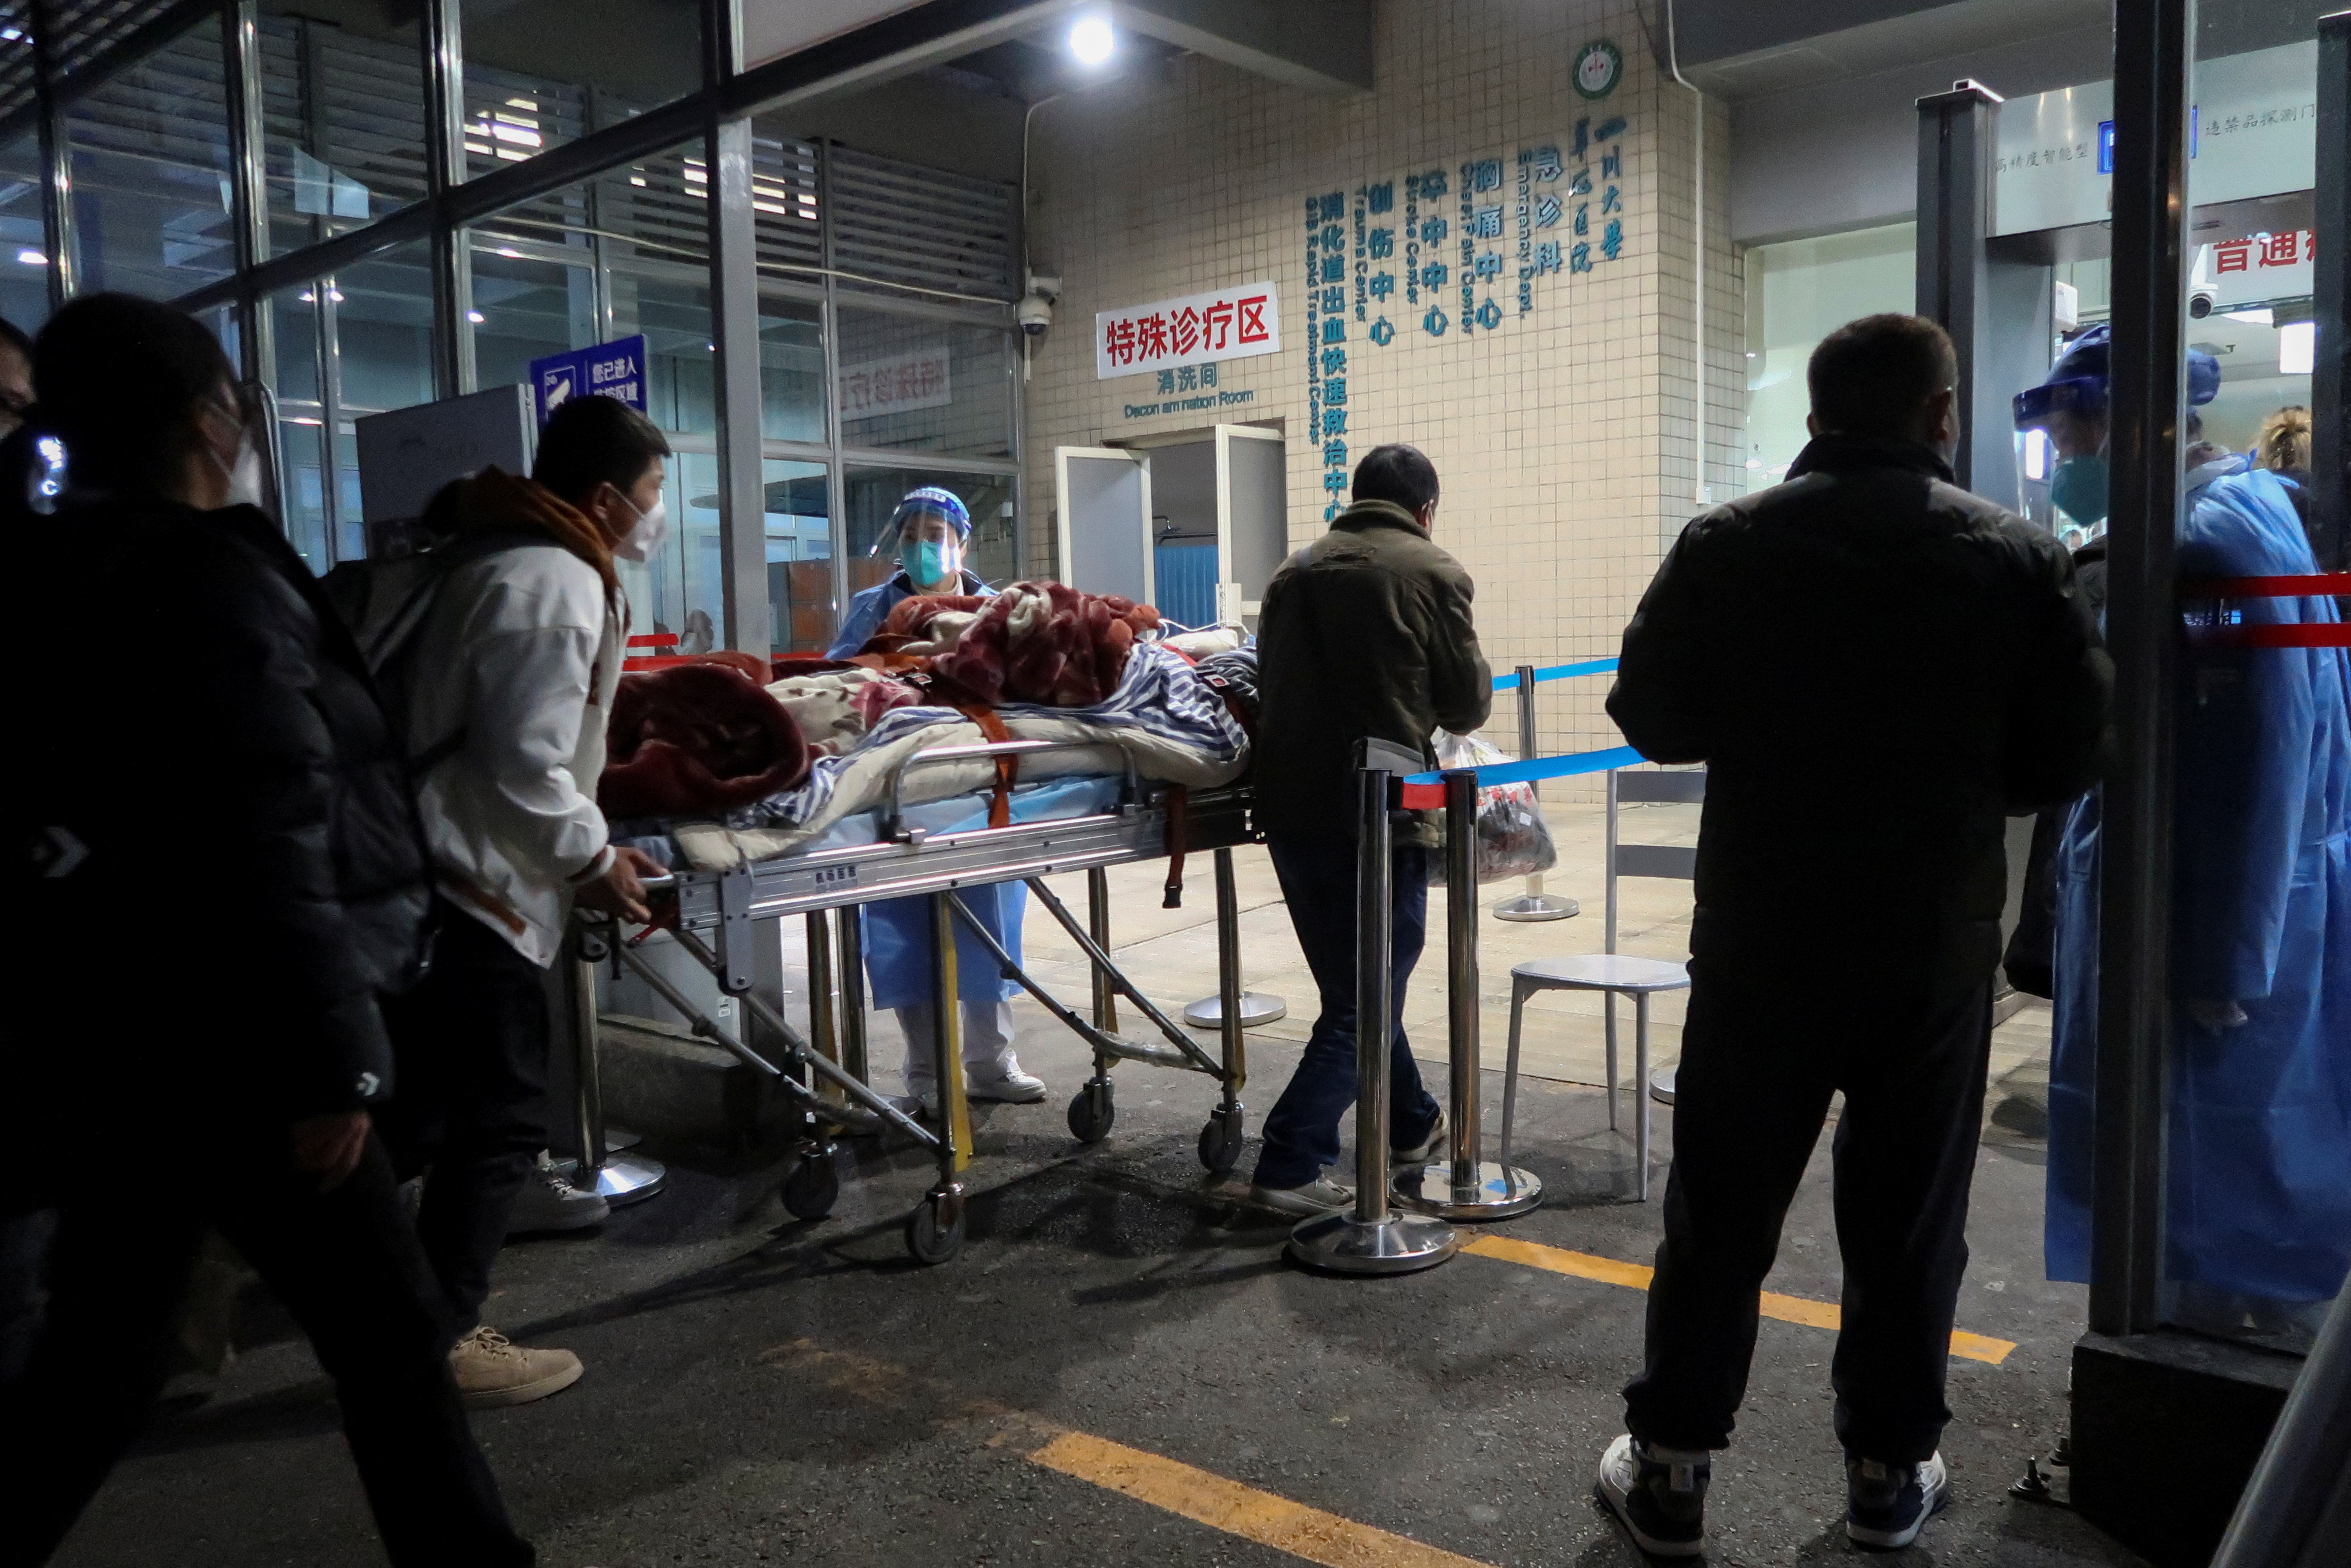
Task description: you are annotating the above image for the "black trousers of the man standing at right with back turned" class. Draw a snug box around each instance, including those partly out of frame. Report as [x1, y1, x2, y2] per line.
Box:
[1625, 954, 1991, 1465]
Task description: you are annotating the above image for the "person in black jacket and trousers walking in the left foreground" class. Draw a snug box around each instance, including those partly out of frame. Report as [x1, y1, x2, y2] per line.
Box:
[0, 294, 534, 1568]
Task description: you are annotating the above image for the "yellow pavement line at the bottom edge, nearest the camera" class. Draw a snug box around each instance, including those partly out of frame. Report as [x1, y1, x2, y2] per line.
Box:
[1030, 1432, 1486, 1568]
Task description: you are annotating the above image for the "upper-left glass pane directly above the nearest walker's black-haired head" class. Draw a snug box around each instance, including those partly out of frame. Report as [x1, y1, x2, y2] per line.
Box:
[66, 16, 235, 299]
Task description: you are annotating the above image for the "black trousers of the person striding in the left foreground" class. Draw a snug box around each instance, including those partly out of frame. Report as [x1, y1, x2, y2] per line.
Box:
[0, 1124, 534, 1568]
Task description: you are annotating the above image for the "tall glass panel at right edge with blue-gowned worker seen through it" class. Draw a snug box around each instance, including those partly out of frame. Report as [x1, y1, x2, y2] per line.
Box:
[2163, 0, 2351, 1349]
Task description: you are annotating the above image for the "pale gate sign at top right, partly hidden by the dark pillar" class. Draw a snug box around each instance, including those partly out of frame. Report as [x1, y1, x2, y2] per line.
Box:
[1991, 40, 2318, 235]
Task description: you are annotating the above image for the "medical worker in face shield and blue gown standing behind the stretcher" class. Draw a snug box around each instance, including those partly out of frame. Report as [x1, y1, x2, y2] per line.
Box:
[827, 484, 1044, 1112]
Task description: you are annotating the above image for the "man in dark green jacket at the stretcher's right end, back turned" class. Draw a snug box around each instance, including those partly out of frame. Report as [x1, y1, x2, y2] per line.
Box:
[1251, 446, 1493, 1215]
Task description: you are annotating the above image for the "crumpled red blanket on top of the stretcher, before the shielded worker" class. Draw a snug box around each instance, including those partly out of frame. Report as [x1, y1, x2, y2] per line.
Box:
[931, 583, 1159, 708]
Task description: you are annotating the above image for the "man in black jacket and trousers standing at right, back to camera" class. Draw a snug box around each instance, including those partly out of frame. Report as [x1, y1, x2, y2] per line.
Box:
[1601, 315, 2111, 1556]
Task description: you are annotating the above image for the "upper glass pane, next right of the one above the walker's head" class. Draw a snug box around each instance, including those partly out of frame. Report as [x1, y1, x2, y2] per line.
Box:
[261, 0, 426, 254]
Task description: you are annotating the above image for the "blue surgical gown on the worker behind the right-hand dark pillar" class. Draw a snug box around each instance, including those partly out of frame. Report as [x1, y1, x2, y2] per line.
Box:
[2045, 458, 2351, 1302]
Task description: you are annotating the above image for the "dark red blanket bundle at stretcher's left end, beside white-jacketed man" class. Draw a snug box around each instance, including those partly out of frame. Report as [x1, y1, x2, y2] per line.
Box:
[595, 663, 809, 816]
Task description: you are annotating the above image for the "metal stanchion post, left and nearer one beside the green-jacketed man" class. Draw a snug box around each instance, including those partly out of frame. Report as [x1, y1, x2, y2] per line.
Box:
[1289, 743, 1460, 1274]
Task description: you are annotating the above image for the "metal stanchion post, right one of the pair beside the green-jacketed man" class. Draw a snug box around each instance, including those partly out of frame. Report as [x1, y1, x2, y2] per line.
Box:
[1397, 769, 1542, 1220]
